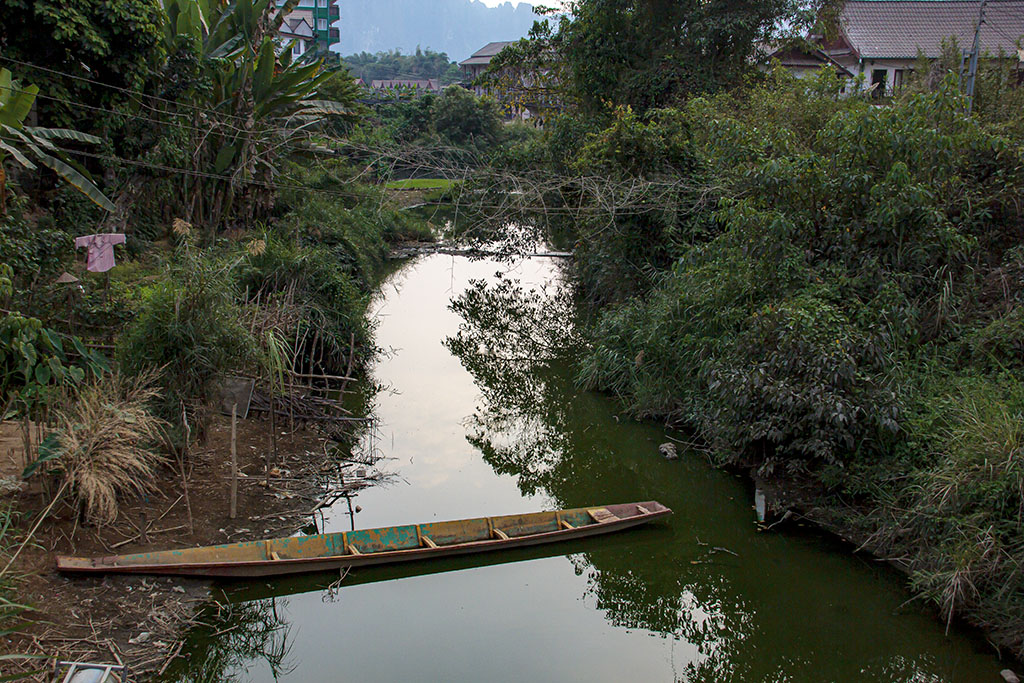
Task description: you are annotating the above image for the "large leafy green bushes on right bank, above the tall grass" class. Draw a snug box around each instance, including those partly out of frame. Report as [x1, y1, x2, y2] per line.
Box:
[579, 75, 1024, 466]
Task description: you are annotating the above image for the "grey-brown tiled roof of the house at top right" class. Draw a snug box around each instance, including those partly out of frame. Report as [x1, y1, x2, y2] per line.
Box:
[840, 0, 1024, 59]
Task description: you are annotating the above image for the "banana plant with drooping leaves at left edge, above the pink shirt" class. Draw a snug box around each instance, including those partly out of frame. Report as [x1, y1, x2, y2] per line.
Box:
[0, 69, 114, 215]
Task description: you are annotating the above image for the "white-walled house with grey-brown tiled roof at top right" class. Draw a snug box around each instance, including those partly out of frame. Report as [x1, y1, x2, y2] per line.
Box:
[822, 0, 1024, 94]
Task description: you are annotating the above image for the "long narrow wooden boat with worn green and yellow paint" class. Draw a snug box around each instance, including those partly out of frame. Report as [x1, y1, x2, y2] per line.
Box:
[56, 501, 672, 578]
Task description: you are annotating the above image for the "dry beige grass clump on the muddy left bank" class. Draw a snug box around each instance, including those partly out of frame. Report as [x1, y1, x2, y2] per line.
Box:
[47, 374, 166, 523]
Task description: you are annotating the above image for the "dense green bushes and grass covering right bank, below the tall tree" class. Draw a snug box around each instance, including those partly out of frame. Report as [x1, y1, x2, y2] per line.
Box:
[561, 73, 1024, 652]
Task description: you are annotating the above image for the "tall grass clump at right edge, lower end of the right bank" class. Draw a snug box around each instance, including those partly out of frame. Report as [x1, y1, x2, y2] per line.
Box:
[891, 380, 1024, 645]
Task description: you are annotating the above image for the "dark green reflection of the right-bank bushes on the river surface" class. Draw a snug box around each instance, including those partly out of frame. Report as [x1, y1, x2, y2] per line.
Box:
[445, 266, 1003, 681]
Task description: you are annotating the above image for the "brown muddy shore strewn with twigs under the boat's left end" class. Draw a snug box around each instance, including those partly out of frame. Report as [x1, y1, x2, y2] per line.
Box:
[0, 416, 376, 681]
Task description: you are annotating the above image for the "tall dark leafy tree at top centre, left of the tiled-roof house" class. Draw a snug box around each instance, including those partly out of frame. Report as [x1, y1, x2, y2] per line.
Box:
[507, 0, 807, 114]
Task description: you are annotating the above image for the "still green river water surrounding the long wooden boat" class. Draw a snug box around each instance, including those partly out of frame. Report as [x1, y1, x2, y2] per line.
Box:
[168, 255, 1002, 682]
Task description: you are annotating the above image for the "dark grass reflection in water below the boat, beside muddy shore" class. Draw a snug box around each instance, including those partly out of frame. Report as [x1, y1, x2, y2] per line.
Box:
[168, 598, 295, 683]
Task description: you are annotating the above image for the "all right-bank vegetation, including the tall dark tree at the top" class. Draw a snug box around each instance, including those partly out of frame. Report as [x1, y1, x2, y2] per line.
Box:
[464, 2, 1024, 657]
